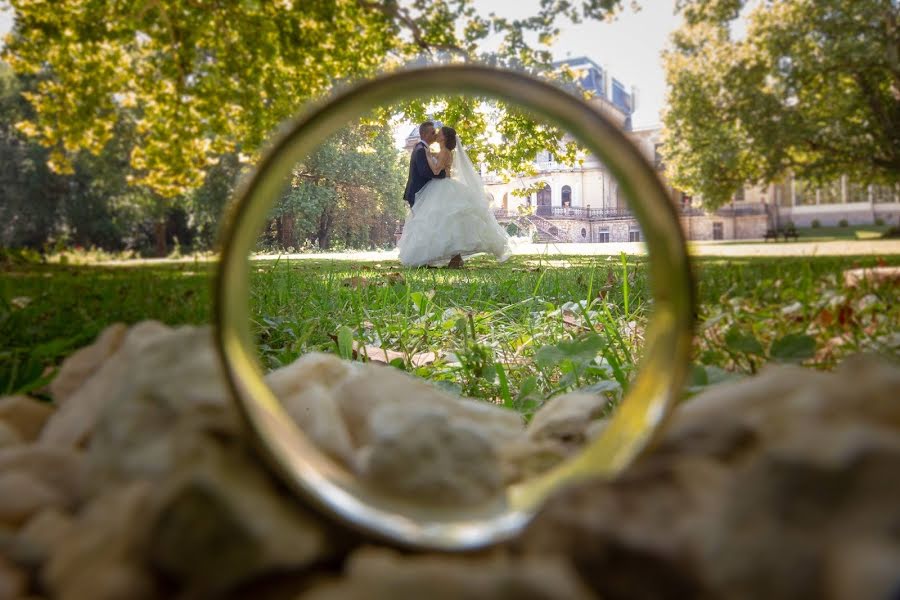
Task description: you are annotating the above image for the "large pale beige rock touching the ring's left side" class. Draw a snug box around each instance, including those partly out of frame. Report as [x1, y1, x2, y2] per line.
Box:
[84, 326, 240, 484]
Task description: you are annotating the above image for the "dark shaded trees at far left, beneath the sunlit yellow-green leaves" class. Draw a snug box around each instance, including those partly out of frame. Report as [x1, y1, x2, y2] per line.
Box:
[0, 63, 211, 254]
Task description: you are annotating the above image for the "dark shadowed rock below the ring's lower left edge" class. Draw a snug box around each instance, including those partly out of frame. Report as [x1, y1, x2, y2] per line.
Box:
[147, 439, 340, 598]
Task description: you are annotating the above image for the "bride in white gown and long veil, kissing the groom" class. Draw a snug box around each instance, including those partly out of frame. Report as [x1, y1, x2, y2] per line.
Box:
[397, 127, 510, 267]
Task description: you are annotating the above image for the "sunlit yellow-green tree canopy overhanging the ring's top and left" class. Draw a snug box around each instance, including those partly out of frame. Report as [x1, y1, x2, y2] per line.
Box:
[4, 0, 621, 198]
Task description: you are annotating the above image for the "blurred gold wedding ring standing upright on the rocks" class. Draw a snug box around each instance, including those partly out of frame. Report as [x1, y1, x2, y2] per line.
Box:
[215, 65, 694, 550]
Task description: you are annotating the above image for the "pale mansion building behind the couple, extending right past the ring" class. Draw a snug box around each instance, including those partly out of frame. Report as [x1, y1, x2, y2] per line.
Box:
[406, 57, 900, 243]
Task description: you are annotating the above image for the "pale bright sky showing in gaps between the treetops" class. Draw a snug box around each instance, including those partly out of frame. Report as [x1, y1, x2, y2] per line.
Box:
[0, 0, 679, 135]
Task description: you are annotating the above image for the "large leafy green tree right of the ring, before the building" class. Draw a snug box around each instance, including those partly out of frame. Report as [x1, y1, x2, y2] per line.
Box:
[664, 0, 900, 207]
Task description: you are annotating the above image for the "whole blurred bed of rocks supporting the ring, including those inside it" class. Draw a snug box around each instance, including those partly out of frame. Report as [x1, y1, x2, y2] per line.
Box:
[0, 322, 900, 600]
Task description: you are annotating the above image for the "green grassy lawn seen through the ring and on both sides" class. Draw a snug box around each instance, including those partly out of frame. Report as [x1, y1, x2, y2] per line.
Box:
[0, 251, 900, 413]
